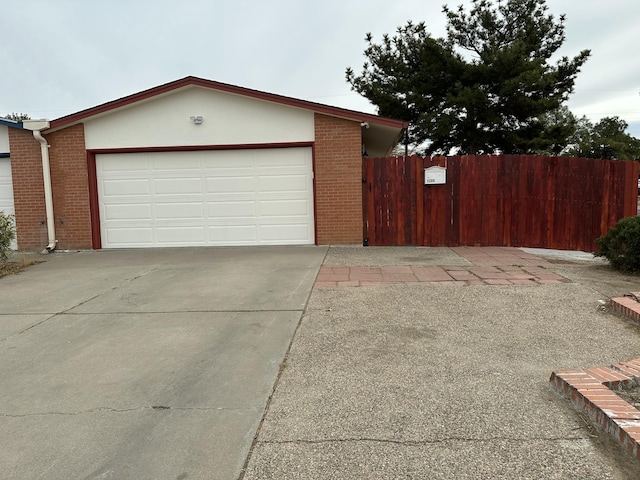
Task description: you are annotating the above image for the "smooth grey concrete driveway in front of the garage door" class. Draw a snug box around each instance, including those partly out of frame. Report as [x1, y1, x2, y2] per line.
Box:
[0, 247, 327, 480]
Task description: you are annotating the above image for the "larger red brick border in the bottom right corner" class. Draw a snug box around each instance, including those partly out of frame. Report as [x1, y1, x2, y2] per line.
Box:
[549, 358, 640, 459]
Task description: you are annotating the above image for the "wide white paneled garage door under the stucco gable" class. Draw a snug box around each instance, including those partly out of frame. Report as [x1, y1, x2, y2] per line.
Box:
[96, 148, 315, 248]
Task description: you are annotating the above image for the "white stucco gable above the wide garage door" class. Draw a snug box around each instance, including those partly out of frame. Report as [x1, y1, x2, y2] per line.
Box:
[85, 85, 314, 149]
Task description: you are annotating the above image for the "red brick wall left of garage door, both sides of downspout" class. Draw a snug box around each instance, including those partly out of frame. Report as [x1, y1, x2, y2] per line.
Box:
[9, 124, 91, 250]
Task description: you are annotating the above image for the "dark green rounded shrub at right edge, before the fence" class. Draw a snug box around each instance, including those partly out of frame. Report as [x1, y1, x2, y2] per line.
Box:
[595, 217, 640, 272]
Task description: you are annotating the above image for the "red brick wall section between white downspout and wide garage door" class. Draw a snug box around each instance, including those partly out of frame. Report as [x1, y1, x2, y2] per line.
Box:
[46, 124, 91, 250]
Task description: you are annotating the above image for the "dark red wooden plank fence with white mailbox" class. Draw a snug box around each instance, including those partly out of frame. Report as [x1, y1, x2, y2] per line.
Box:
[363, 155, 638, 251]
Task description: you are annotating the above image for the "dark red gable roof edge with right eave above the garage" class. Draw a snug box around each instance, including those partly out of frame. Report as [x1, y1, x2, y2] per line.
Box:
[49, 76, 408, 156]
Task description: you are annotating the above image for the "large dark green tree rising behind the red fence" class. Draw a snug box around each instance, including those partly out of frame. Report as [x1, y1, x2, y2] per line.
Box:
[346, 0, 590, 154]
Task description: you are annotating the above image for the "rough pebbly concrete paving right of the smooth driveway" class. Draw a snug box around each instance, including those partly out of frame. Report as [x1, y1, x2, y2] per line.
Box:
[242, 247, 640, 480]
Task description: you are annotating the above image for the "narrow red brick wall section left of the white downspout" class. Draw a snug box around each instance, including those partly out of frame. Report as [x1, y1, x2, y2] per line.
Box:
[9, 128, 48, 250]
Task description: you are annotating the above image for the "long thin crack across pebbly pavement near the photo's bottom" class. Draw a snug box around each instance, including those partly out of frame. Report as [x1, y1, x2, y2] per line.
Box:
[257, 436, 587, 447]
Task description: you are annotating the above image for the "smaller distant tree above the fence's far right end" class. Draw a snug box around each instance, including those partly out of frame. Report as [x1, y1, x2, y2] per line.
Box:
[564, 117, 640, 160]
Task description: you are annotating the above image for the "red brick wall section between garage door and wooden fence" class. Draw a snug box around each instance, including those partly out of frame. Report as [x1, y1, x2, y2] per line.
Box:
[315, 114, 363, 245]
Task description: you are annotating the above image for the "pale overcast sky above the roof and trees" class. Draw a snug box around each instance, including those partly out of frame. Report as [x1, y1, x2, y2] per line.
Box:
[0, 0, 640, 137]
